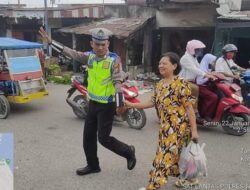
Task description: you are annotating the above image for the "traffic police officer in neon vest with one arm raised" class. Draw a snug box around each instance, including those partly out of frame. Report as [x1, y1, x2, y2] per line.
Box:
[39, 27, 136, 175]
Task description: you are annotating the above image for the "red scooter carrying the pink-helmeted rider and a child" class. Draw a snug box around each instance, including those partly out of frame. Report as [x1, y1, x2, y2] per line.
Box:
[198, 74, 250, 136]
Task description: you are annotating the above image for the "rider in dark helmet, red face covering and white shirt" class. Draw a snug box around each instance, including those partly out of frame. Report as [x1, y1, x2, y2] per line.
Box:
[215, 44, 246, 82]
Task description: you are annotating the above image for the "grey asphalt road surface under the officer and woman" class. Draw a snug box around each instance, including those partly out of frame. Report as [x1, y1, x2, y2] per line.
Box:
[0, 84, 250, 190]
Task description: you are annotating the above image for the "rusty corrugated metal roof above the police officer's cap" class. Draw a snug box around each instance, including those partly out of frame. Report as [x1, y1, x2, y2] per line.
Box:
[58, 18, 148, 39]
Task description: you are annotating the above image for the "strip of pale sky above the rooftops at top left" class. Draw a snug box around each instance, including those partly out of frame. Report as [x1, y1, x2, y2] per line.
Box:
[0, 0, 124, 7]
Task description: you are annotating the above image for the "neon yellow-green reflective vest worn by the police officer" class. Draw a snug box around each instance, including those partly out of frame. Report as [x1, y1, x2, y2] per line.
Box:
[88, 54, 115, 103]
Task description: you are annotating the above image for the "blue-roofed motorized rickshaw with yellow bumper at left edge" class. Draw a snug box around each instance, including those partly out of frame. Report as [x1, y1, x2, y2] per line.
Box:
[0, 38, 48, 119]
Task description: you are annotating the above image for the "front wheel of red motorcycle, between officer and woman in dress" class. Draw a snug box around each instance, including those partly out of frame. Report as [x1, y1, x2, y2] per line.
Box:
[126, 108, 147, 129]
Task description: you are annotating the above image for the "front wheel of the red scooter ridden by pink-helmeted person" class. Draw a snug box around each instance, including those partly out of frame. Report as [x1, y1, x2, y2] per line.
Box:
[221, 113, 249, 136]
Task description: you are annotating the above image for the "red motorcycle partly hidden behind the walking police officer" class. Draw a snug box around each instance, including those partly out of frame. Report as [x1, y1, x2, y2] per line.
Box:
[66, 68, 146, 129]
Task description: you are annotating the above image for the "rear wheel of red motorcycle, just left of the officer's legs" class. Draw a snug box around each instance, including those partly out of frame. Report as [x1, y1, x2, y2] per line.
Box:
[73, 95, 88, 119]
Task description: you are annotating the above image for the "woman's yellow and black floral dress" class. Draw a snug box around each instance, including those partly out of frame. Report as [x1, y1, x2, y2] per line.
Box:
[147, 77, 195, 189]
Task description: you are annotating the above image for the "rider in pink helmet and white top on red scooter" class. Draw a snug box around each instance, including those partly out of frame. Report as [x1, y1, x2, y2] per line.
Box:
[179, 40, 216, 122]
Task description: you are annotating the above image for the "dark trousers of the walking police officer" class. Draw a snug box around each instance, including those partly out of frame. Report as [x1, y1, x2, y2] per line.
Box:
[83, 100, 131, 168]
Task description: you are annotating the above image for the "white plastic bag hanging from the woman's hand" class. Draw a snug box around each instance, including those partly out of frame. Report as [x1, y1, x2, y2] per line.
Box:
[179, 141, 207, 179]
